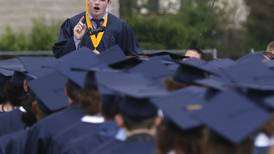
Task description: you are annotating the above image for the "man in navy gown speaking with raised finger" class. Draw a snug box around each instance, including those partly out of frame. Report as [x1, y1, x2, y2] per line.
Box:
[53, 0, 141, 58]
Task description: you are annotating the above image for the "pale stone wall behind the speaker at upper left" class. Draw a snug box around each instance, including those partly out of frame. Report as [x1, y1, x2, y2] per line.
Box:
[0, 0, 119, 34]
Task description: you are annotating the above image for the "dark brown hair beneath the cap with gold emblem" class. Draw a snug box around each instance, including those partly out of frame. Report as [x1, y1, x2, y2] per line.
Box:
[156, 119, 207, 154]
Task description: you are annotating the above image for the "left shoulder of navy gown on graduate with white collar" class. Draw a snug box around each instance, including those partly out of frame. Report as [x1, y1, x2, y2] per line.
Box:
[24, 104, 83, 154]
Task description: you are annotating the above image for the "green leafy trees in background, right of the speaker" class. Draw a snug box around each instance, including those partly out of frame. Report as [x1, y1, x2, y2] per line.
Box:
[126, 0, 216, 49]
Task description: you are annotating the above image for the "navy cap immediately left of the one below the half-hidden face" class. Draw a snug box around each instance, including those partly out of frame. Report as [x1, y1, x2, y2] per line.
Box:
[129, 57, 174, 79]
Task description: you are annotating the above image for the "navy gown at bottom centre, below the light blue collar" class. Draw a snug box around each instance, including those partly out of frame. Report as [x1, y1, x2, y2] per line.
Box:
[89, 134, 156, 154]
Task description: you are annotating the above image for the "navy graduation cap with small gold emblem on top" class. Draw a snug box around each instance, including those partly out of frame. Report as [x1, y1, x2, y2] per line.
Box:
[152, 89, 206, 130]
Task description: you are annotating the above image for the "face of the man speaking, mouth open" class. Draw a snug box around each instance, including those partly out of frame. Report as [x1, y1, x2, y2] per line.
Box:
[88, 0, 111, 19]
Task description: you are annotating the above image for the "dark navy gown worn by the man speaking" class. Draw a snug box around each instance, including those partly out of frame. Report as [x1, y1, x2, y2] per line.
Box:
[53, 12, 141, 58]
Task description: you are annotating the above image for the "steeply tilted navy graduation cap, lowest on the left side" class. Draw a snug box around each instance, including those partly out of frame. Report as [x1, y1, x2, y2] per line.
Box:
[29, 71, 68, 113]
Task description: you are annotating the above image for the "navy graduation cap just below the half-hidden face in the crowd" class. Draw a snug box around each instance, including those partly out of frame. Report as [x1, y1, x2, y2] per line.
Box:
[173, 59, 215, 83]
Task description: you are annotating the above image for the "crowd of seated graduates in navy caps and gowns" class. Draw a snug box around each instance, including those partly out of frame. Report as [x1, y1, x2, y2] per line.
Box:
[0, 42, 274, 154]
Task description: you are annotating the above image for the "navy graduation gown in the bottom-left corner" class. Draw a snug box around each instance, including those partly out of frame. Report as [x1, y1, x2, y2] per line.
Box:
[0, 130, 27, 154]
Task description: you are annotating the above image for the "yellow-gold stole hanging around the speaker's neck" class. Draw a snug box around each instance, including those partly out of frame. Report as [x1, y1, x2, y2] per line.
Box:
[86, 0, 108, 50]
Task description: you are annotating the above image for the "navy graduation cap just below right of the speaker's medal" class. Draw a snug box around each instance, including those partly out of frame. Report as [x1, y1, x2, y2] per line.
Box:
[98, 45, 126, 64]
